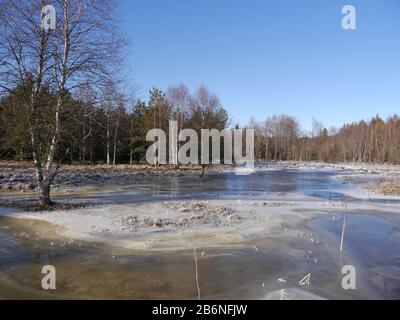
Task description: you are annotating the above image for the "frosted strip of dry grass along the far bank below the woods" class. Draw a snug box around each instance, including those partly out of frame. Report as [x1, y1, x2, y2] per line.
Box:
[0, 161, 400, 199]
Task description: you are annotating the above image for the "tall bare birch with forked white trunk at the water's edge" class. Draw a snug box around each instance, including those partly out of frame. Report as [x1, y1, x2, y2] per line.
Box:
[0, 0, 125, 206]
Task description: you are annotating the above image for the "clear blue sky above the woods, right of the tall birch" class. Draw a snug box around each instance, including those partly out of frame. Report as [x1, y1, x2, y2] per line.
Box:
[120, 0, 400, 130]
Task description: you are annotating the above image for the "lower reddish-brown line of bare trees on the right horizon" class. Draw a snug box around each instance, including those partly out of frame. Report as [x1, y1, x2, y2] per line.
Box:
[249, 115, 400, 164]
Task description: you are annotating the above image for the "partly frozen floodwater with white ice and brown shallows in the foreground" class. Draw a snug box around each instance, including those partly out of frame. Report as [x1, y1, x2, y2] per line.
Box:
[0, 169, 400, 299]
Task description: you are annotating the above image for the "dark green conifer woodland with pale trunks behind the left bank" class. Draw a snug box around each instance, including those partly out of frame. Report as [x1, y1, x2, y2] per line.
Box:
[0, 85, 229, 164]
